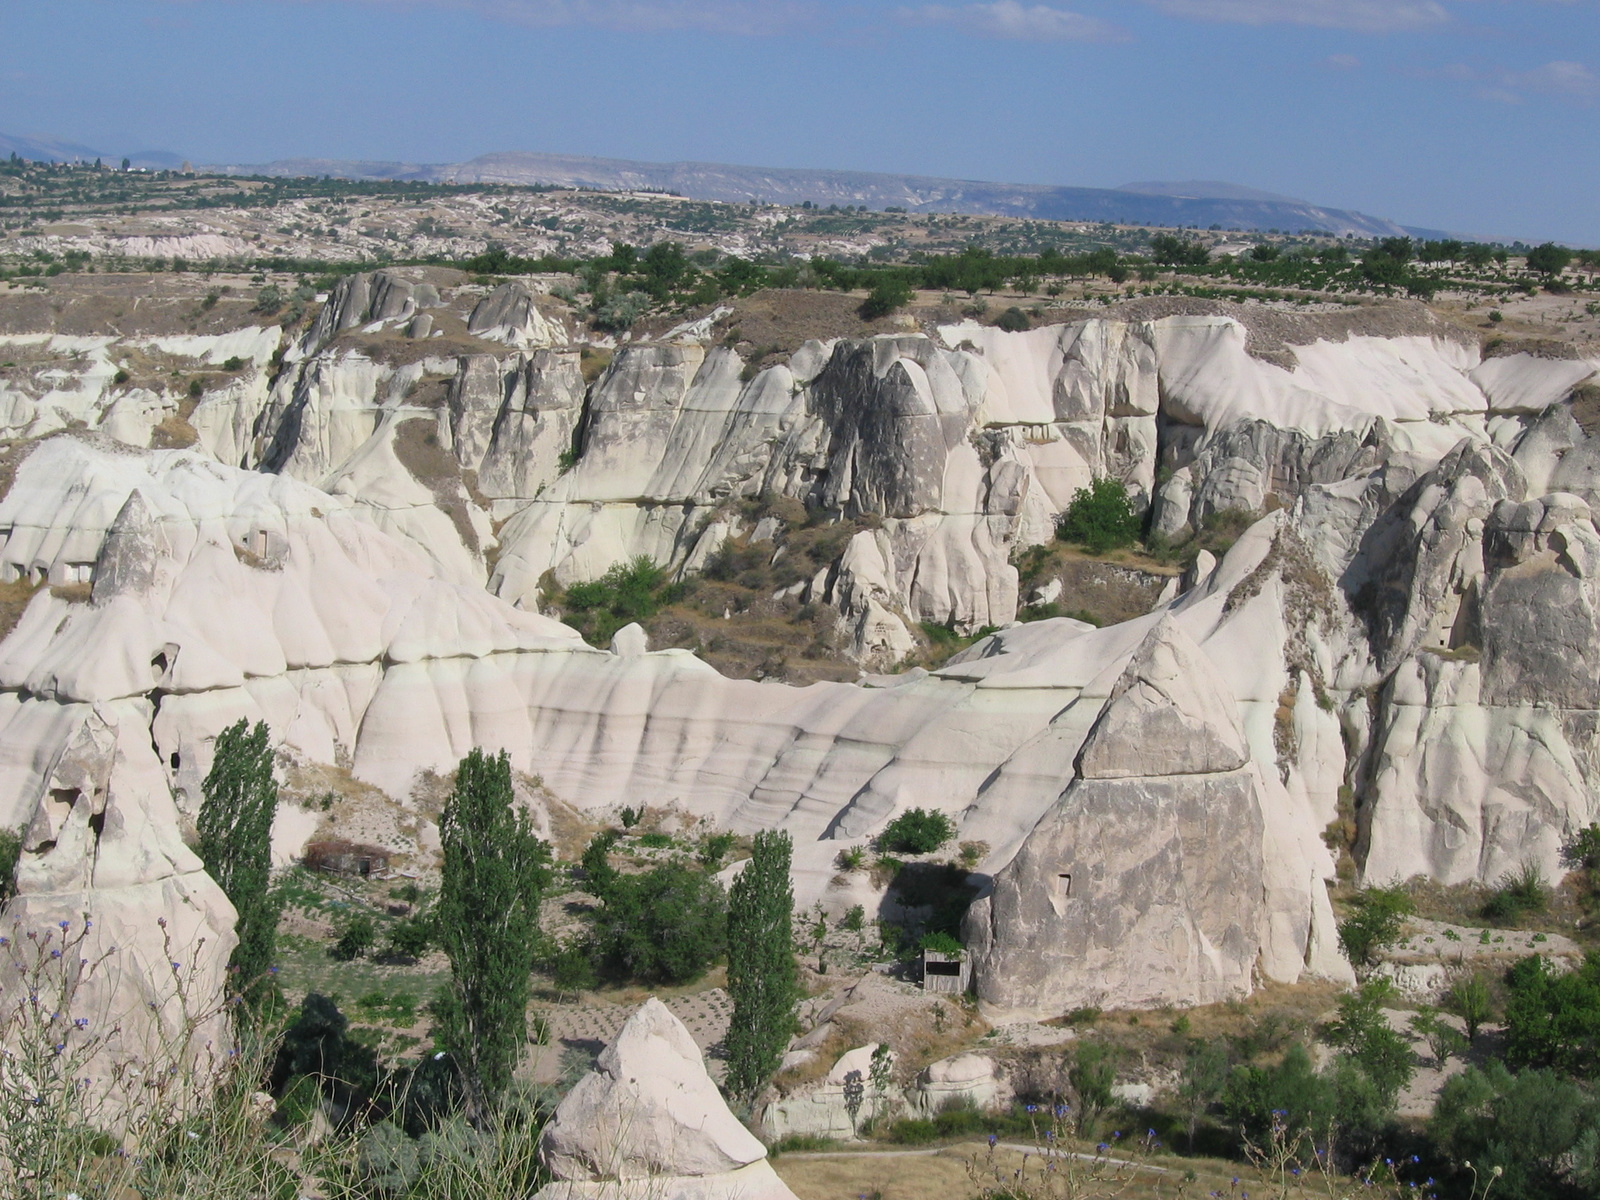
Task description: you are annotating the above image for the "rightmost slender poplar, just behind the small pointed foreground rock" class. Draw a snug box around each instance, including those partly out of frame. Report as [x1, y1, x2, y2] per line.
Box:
[726, 830, 800, 1102]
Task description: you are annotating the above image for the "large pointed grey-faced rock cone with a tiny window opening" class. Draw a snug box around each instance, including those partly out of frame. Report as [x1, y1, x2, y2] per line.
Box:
[966, 618, 1266, 1013]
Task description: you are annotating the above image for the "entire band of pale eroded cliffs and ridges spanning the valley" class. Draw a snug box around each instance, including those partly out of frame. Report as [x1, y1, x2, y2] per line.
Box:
[0, 278, 1600, 1008]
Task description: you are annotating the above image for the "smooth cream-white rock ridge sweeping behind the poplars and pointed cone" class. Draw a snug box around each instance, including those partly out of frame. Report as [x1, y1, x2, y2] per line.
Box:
[0, 437, 1356, 1017]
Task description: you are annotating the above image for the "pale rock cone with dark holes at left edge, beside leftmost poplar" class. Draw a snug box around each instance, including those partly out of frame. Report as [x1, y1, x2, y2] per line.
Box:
[0, 699, 237, 1122]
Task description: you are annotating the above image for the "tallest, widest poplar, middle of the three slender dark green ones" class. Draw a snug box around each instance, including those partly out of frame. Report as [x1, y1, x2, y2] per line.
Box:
[437, 749, 550, 1125]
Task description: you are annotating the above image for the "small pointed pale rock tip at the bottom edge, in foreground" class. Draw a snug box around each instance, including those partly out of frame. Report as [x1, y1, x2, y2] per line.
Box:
[539, 998, 792, 1200]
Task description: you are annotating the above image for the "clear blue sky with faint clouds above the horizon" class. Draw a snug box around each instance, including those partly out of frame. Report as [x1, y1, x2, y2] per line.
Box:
[0, 0, 1600, 245]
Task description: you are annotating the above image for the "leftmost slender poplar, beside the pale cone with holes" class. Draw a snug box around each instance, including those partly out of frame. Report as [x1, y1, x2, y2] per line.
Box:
[195, 717, 278, 1014]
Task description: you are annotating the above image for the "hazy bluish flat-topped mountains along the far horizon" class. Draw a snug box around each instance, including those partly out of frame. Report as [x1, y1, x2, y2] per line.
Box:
[0, 134, 1465, 237]
